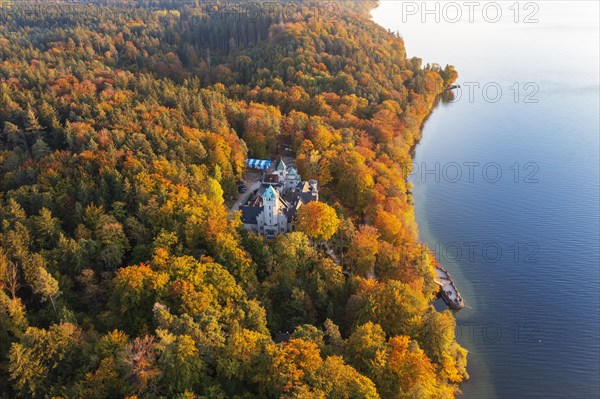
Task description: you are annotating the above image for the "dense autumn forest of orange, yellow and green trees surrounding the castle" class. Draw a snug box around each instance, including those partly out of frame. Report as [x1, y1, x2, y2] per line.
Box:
[0, 0, 468, 399]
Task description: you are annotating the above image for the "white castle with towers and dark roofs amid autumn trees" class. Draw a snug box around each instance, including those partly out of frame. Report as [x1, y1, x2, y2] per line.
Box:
[240, 160, 319, 238]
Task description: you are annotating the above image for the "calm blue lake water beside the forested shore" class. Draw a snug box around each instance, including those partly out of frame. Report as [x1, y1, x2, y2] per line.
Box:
[373, 0, 600, 399]
